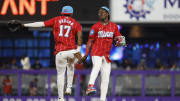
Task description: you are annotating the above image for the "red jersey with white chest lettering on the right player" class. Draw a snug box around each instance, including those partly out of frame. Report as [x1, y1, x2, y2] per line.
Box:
[89, 22, 121, 60]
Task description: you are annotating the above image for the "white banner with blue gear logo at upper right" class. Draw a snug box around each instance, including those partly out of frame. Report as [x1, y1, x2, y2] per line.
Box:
[110, 0, 180, 23]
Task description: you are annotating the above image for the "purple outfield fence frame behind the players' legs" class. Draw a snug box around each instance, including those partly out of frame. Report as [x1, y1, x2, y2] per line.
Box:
[0, 70, 180, 101]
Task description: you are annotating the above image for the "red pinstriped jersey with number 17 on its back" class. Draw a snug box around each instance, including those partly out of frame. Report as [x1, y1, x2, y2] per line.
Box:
[44, 16, 82, 54]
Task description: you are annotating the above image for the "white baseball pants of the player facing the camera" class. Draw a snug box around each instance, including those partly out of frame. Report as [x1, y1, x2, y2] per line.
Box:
[89, 56, 111, 101]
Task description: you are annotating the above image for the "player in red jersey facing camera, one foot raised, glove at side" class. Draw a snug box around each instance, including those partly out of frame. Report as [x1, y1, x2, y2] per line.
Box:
[82, 6, 125, 101]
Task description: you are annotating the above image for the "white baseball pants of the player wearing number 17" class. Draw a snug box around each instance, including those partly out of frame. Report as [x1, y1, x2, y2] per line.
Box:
[55, 50, 77, 99]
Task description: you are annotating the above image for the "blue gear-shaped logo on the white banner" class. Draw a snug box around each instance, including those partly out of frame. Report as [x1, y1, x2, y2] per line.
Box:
[124, 0, 155, 20]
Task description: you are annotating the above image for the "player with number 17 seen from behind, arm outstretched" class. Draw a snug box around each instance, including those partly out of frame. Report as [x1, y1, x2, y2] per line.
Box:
[20, 6, 82, 101]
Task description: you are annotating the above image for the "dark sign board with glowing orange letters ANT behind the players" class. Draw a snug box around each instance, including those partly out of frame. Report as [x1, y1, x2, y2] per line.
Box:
[0, 0, 109, 23]
